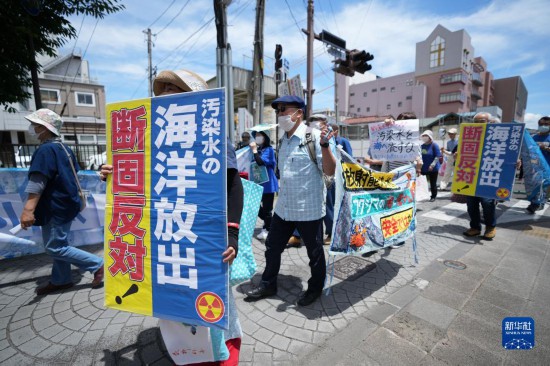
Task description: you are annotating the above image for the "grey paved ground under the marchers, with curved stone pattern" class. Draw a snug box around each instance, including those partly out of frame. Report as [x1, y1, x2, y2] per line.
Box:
[0, 189, 550, 366]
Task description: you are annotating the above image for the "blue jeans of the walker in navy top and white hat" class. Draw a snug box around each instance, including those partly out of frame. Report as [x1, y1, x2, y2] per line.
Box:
[42, 221, 103, 285]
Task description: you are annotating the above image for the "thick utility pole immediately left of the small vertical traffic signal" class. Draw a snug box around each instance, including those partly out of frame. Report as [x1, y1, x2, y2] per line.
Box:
[252, 0, 265, 125]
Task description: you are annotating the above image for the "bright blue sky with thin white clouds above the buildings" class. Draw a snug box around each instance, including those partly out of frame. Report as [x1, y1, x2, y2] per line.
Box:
[61, 0, 550, 126]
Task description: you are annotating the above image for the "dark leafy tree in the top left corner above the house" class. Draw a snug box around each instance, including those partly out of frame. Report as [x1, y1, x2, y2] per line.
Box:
[0, 0, 124, 109]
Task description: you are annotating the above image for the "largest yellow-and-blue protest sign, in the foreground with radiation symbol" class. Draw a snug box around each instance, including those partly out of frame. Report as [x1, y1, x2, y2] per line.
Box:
[105, 89, 228, 329]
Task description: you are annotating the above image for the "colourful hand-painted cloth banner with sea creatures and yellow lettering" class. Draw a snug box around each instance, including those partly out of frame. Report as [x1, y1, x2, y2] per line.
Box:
[329, 148, 416, 254]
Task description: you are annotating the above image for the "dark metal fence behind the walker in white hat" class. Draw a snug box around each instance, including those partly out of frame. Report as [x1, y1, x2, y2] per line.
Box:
[0, 144, 106, 170]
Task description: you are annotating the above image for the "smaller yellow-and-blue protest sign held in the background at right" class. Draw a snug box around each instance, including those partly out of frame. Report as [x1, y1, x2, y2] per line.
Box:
[451, 123, 525, 201]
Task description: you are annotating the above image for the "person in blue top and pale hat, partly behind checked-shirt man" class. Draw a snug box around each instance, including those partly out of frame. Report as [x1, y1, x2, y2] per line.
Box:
[249, 131, 279, 240]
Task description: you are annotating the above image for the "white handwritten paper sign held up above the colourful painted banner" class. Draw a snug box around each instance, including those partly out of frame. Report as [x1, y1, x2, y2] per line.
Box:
[369, 119, 420, 161]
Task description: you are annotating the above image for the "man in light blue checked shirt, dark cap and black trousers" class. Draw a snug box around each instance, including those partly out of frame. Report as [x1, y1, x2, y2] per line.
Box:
[246, 96, 336, 306]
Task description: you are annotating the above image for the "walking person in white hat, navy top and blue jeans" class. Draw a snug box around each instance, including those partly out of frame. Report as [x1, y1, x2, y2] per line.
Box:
[20, 108, 103, 295]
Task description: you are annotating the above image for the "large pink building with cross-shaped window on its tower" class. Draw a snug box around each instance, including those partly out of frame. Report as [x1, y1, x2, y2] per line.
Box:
[338, 25, 527, 121]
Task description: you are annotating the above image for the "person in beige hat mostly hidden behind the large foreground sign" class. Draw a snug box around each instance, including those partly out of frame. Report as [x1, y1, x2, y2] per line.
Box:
[100, 70, 243, 365]
